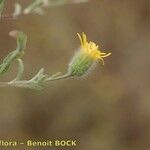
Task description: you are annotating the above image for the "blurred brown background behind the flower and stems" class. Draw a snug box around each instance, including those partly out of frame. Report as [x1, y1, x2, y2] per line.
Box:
[0, 0, 150, 150]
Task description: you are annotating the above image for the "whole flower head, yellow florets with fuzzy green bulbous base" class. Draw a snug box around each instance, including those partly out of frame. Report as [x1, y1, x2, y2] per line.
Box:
[68, 33, 111, 77]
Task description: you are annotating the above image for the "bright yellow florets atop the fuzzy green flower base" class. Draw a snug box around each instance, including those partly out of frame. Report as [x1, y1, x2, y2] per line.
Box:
[77, 33, 111, 64]
